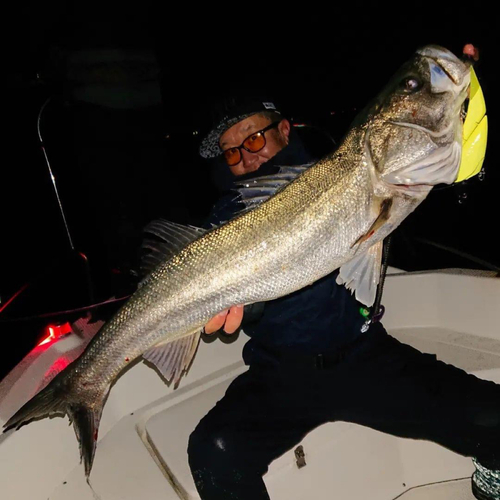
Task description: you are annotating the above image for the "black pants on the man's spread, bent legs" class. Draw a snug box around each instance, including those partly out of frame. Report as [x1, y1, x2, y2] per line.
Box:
[188, 328, 500, 500]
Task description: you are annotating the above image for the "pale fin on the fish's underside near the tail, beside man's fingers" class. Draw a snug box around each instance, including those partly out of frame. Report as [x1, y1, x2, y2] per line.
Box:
[142, 330, 201, 387]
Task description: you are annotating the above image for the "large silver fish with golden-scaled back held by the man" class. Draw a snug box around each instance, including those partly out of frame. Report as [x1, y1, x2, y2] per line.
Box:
[5, 46, 470, 477]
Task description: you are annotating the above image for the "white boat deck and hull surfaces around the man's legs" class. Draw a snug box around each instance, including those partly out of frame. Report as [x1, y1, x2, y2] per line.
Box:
[0, 273, 500, 500]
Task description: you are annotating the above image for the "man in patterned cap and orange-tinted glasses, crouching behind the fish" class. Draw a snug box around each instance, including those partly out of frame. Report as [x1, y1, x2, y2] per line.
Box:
[188, 95, 500, 500]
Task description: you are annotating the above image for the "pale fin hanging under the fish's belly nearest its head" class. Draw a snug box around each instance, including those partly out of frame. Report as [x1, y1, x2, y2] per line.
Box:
[337, 241, 384, 307]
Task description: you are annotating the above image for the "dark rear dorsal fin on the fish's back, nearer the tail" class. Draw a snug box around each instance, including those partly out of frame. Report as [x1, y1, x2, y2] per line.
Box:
[140, 219, 206, 277]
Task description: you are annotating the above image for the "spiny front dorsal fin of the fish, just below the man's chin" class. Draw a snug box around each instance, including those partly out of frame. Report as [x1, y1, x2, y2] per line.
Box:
[236, 163, 314, 209]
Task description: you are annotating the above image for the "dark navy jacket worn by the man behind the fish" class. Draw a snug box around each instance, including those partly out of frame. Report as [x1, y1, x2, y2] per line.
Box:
[207, 129, 365, 364]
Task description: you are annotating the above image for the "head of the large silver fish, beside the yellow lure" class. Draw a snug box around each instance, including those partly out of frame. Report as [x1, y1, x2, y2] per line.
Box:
[364, 45, 470, 194]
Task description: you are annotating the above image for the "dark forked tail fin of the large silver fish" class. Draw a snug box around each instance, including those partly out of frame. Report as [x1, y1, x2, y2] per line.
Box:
[4, 377, 109, 478]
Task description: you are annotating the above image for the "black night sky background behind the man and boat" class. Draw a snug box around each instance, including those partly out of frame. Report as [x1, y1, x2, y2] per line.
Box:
[0, 1, 500, 378]
